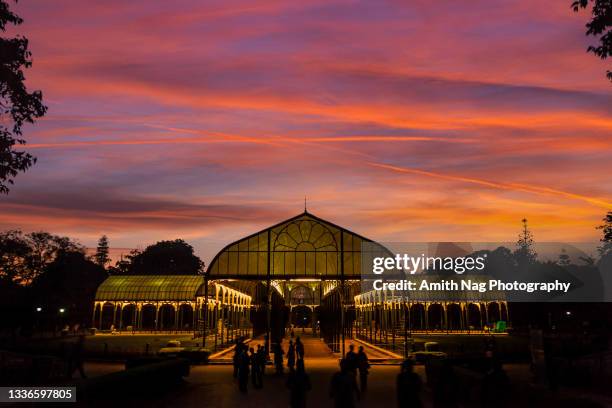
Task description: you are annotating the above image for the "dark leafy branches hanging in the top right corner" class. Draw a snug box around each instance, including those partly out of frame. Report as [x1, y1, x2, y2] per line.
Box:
[572, 0, 612, 81]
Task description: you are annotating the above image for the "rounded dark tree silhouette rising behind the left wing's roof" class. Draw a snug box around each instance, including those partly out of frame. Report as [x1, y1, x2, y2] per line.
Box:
[118, 239, 204, 275]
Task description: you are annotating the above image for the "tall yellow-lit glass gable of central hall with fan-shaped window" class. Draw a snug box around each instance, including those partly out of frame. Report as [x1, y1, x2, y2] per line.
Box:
[207, 212, 388, 279]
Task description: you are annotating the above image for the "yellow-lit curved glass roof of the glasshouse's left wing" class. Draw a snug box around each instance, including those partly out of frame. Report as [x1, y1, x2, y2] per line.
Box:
[96, 275, 204, 301]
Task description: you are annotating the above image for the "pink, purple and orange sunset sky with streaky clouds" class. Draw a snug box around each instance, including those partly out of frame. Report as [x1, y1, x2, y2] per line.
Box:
[0, 0, 612, 263]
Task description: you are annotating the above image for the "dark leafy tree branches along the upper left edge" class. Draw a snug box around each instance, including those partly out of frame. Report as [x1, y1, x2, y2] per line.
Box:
[0, 0, 47, 194]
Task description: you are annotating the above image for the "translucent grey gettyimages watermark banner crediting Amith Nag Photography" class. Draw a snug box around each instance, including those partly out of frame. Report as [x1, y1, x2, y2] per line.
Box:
[361, 242, 612, 302]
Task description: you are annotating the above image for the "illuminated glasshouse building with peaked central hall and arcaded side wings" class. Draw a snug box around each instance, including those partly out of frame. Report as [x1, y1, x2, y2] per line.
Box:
[93, 212, 509, 351]
